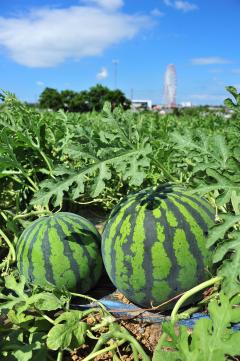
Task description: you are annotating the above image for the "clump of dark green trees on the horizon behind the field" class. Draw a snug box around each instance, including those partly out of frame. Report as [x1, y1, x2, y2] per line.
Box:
[38, 84, 131, 113]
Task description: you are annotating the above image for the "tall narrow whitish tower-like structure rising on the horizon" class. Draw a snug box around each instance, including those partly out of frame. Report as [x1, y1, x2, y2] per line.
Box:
[164, 64, 177, 108]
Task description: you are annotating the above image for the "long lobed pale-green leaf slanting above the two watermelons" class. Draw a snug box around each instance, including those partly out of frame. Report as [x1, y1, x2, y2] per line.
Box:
[31, 144, 152, 207]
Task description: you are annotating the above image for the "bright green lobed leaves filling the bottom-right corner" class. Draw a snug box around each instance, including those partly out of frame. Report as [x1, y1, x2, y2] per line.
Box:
[153, 293, 240, 361]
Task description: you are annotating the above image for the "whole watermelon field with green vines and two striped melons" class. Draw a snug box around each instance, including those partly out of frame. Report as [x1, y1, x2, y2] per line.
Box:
[0, 86, 240, 361]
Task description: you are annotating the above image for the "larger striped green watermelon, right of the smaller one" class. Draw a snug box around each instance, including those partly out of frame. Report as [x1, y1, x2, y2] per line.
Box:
[102, 184, 214, 307]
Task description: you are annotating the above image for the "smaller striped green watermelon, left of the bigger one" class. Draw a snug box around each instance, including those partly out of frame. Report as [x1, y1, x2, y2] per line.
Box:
[17, 212, 102, 292]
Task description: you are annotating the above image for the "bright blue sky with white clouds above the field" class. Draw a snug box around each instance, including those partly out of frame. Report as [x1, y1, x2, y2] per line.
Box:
[0, 0, 240, 104]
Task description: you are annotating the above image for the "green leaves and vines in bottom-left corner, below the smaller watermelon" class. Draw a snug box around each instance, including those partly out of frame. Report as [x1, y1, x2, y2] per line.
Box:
[0, 275, 150, 361]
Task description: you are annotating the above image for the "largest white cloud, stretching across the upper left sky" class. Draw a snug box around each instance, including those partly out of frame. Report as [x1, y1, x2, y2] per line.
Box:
[0, 0, 151, 67]
